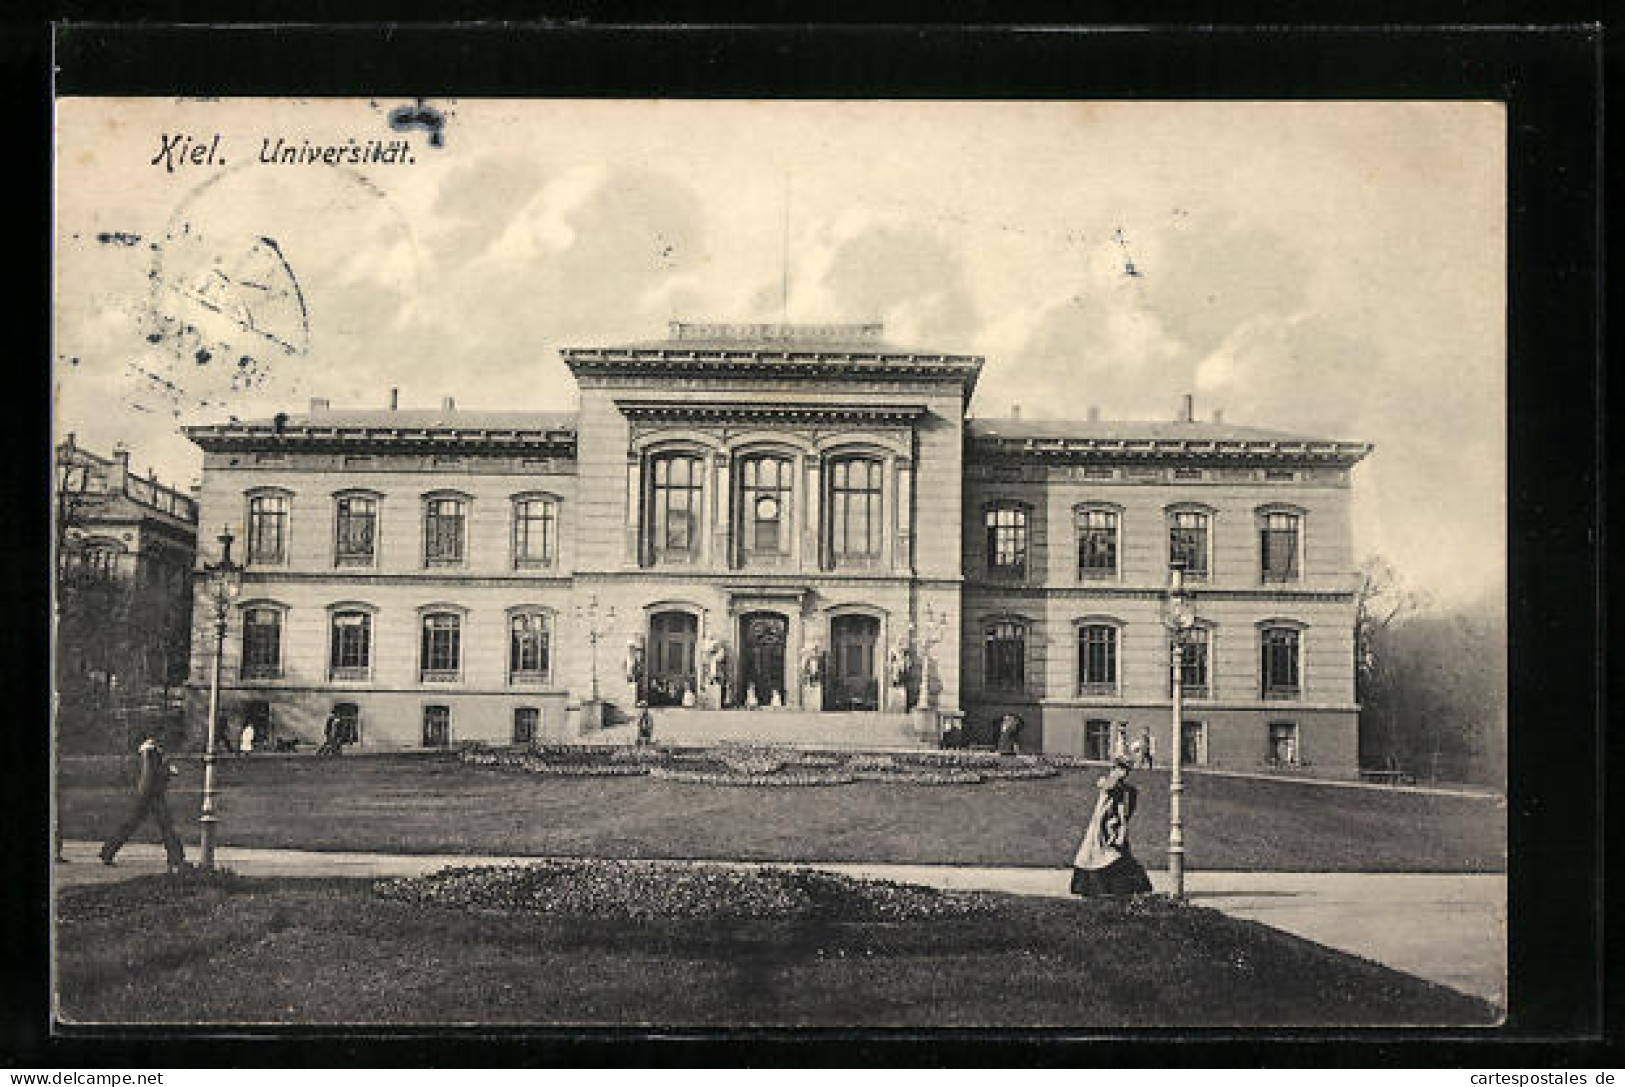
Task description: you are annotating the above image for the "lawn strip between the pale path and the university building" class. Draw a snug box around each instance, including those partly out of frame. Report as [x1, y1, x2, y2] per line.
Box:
[62, 756, 1506, 873]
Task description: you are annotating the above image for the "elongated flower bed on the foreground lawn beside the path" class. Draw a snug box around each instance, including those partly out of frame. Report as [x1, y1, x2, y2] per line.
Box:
[372, 860, 991, 921]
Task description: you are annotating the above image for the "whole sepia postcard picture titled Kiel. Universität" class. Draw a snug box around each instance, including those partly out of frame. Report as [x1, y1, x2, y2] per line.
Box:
[50, 96, 1508, 1032]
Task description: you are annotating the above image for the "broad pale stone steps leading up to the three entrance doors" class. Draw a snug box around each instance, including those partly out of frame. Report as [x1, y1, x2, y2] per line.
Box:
[637, 708, 936, 751]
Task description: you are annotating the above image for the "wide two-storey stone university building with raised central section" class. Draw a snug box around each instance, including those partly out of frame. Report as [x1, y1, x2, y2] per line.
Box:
[187, 323, 1370, 775]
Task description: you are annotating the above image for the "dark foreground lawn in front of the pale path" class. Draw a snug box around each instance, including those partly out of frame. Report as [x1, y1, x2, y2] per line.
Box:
[57, 864, 1497, 1029]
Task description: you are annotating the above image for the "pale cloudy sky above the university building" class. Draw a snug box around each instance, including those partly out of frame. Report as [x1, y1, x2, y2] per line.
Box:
[54, 99, 1505, 601]
